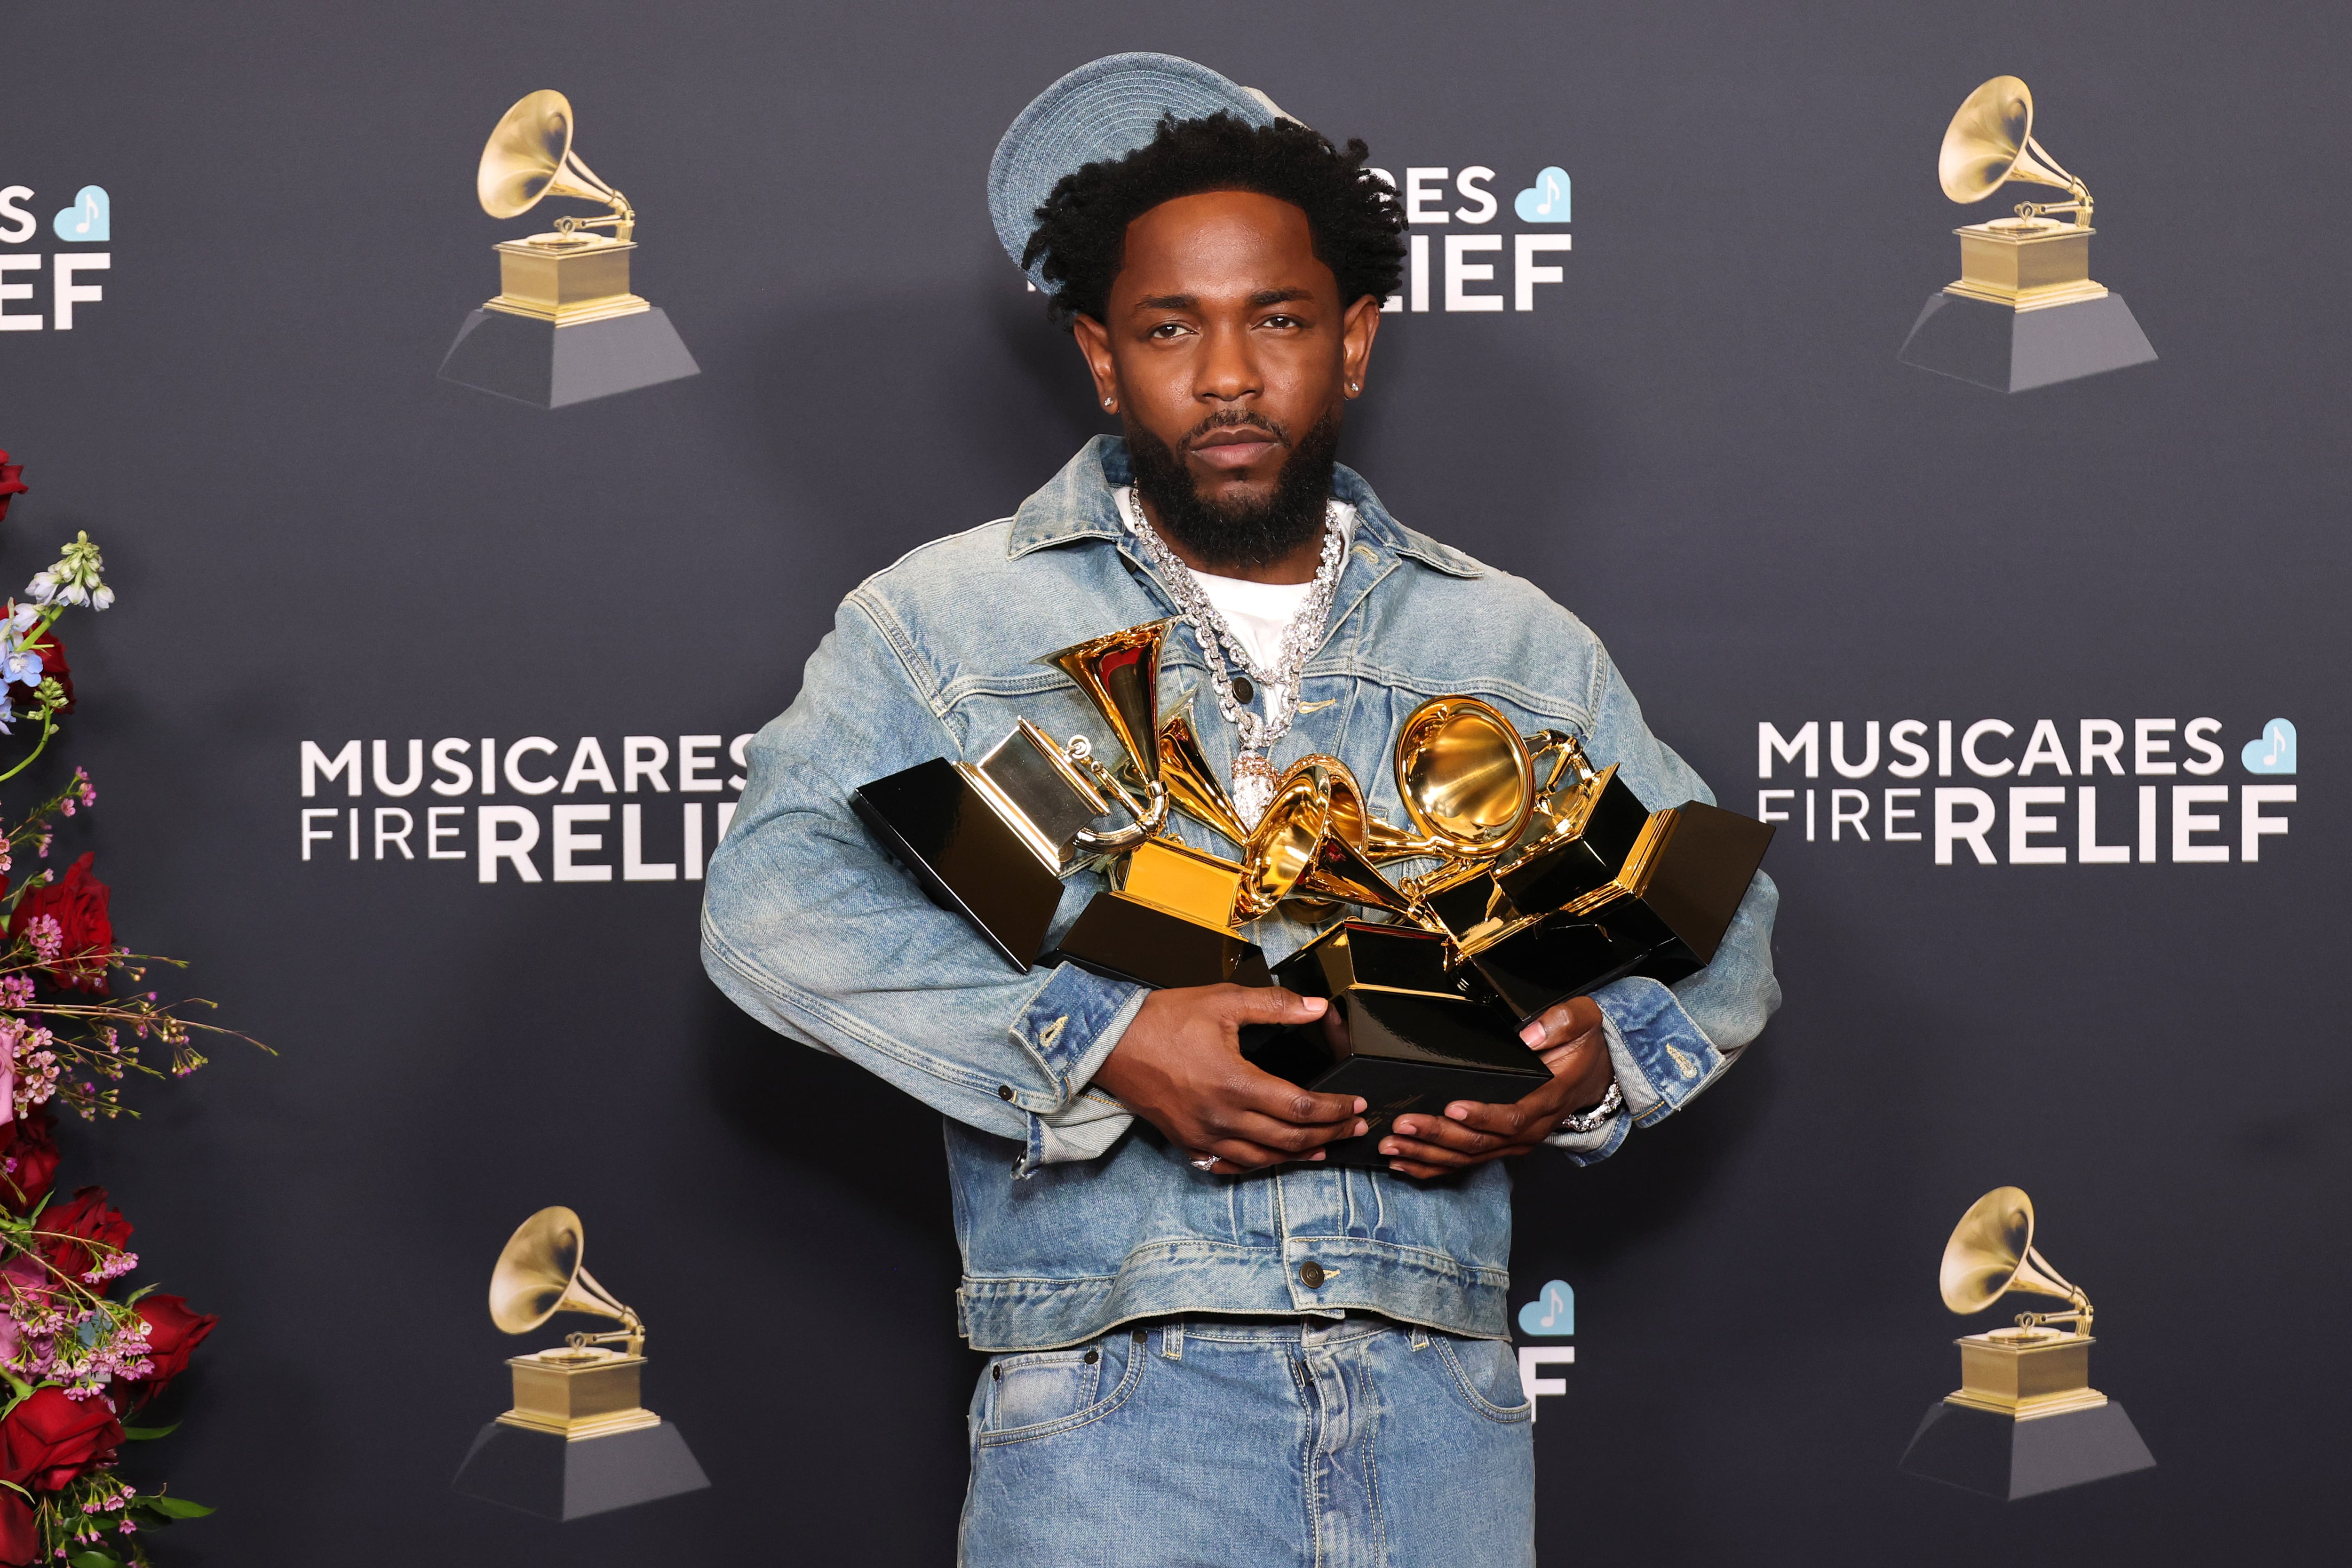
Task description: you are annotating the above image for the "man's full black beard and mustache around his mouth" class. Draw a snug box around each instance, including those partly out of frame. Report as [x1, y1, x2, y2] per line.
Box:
[1124, 409, 1338, 566]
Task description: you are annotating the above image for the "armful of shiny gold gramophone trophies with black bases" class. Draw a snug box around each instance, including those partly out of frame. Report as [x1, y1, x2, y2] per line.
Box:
[851, 621, 1773, 1169]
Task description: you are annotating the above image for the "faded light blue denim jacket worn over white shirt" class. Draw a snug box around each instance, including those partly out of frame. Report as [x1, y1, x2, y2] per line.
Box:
[703, 437, 1780, 1352]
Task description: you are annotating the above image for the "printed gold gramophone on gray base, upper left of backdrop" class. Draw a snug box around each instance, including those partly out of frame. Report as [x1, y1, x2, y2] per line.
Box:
[440, 92, 699, 406]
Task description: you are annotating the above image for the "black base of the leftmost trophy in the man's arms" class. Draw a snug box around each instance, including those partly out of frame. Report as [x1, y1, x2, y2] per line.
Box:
[849, 757, 1061, 973]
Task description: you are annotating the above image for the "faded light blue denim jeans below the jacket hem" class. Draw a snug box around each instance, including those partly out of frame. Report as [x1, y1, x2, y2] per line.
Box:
[957, 1319, 1536, 1568]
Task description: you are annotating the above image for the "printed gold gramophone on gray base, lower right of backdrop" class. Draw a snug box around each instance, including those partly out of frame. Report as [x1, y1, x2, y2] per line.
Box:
[1903, 1187, 2157, 1500]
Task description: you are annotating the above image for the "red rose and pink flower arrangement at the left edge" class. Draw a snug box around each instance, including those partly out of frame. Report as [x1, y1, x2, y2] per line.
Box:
[0, 451, 250, 1568]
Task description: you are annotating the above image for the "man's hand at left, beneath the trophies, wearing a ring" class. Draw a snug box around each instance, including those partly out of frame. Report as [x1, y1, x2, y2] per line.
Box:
[1094, 985, 1364, 1176]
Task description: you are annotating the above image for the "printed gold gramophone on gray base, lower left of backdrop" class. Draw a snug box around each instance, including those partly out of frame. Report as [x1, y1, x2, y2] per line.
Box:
[456, 1208, 710, 1519]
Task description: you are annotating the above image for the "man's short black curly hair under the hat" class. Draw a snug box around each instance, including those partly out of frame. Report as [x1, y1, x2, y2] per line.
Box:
[1021, 113, 1404, 325]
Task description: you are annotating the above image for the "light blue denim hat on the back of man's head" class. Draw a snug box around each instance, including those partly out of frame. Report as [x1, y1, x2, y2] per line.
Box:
[988, 54, 1289, 294]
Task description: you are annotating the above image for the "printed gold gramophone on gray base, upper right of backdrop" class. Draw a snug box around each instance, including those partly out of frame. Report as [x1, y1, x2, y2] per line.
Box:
[1898, 75, 2157, 392]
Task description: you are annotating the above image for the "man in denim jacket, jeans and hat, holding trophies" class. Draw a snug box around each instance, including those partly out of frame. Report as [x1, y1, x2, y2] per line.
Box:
[703, 56, 1778, 1568]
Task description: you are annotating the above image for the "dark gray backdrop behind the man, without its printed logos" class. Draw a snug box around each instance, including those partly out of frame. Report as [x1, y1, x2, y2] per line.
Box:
[0, 2, 2352, 1568]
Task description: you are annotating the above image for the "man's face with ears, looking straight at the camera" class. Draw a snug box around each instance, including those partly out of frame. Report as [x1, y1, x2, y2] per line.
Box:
[1075, 191, 1381, 552]
